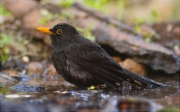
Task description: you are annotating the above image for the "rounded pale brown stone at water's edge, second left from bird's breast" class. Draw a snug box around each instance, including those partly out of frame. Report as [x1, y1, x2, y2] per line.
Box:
[27, 62, 43, 75]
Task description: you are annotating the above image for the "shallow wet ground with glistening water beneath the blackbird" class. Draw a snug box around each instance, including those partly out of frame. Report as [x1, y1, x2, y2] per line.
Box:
[0, 68, 180, 112]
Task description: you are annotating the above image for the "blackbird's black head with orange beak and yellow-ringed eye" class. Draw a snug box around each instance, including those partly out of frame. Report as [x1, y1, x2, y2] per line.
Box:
[37, 23, 79, 42]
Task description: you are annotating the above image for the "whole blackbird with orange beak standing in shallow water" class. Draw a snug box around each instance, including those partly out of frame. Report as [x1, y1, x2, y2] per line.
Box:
[37, 23, 164, 88]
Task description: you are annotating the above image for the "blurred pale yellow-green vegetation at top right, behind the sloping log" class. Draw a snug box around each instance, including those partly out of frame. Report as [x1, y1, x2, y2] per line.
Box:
[82, 0, 180, 23]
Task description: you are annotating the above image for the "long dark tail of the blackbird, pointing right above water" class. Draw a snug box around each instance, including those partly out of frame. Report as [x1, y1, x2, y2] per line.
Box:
[123, 68, 165, 88]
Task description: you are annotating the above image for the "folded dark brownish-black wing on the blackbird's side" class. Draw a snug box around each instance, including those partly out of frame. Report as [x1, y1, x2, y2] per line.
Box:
[64, 42, 123, 86]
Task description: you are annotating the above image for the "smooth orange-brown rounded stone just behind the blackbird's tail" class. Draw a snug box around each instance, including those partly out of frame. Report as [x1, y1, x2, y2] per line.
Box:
[119, 59, 147, 76]
